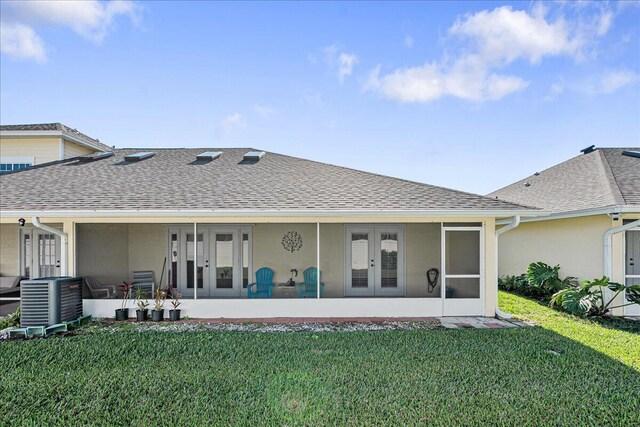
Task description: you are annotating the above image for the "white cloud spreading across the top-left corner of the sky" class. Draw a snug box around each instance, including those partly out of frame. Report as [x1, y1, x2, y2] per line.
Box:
[0, 0, 141, 62]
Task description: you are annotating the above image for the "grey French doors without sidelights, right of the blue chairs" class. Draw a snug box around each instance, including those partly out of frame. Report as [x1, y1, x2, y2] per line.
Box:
[345, 226, 405, 296]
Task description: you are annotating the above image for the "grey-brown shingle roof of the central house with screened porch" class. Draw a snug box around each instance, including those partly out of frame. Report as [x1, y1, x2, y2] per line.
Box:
[0, 148, 527, 211]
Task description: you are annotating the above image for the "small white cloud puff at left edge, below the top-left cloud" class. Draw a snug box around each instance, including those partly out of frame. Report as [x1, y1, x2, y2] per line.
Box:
[0, 22, 47, 63]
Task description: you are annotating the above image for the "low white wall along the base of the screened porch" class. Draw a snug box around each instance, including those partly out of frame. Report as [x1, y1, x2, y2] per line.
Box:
[83, 298, 444, 319]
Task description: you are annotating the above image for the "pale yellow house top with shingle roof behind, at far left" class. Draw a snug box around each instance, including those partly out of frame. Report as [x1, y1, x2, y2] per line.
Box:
[0, 123, 111, 173]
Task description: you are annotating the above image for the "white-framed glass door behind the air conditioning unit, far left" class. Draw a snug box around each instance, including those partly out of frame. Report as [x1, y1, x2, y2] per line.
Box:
[20, 228, 61, 279]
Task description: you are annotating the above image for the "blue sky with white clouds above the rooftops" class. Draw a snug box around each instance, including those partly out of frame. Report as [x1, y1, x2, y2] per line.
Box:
[0, 1, 640, 193]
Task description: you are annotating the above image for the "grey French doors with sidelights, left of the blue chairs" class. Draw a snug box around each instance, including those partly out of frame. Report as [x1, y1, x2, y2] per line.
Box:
[168, 226, 251, 298]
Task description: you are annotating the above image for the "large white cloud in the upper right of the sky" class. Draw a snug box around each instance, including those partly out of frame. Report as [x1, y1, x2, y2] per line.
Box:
[364, 3, 613, 103]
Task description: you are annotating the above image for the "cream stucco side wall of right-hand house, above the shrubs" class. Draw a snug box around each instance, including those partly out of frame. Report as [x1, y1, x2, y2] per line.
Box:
[498, 215, 613, 280]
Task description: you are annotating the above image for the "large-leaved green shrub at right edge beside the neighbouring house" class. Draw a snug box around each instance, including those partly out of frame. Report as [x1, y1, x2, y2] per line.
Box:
[549, 276, 640, 316]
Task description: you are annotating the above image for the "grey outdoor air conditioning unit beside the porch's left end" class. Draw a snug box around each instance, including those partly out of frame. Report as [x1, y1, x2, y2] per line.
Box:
[20, 277, 82, 327]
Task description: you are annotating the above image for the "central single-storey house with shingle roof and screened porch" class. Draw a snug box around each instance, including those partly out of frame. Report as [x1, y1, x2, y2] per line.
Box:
[0, 148, 543, 318]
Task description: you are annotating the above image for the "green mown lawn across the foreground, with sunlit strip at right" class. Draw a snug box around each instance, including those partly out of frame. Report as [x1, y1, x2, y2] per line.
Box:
[0, 293, 640, 426]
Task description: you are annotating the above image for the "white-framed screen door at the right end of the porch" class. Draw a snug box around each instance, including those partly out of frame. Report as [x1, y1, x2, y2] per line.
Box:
[442, 226, 484, 316]
